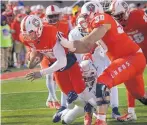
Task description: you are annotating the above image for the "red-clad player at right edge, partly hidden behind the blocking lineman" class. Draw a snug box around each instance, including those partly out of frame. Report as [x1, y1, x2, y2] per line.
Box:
[110, 0, 147, 121]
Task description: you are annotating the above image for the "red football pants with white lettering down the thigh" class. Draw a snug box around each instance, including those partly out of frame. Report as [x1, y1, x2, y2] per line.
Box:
[97, 50, 146, 99]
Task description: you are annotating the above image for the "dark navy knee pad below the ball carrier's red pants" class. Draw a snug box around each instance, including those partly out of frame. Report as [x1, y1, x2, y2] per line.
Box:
[67, 91, 78, 104]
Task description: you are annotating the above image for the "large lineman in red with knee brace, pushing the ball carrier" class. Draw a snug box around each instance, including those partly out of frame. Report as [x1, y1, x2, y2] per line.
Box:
[58, 2, 147, 125]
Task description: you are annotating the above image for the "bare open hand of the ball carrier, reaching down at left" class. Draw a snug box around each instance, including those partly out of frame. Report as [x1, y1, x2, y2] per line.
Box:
[25, 71, 42, 82]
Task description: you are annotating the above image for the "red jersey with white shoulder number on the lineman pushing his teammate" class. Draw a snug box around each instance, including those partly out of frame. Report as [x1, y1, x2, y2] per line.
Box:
[91, 13, 139, 60]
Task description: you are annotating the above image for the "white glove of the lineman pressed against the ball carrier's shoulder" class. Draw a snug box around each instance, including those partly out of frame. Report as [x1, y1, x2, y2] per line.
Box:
[57, 32, 76, 52]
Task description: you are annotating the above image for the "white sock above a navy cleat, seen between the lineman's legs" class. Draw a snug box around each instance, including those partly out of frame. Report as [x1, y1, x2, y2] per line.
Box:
[110, 86, 119, 108]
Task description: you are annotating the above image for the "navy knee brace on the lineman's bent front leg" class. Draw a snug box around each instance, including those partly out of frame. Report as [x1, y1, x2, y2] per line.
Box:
[96, 84, 110, 106]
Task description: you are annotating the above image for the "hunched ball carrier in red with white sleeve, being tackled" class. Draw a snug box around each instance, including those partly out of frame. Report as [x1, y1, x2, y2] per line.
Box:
[21, 15, 95, 121]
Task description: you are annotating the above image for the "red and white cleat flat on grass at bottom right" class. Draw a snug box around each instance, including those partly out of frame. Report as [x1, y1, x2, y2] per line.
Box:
[117, 113, 137, 122]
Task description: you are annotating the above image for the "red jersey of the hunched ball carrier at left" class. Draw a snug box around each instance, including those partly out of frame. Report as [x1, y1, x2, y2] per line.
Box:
[20, 25, 58, 62]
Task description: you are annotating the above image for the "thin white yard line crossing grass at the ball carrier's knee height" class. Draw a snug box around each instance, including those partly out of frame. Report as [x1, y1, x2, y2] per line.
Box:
[1, 86, 147, 95]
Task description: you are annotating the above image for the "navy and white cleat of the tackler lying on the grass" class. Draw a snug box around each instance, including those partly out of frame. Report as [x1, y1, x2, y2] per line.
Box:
[53, 106, 66, 123]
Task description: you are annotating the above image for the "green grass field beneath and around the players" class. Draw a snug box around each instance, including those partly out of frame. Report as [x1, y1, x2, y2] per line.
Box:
[1, 70, 147, 125]
